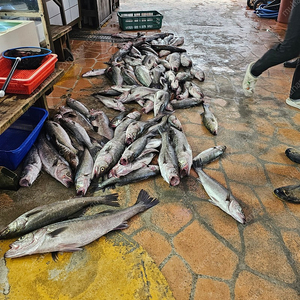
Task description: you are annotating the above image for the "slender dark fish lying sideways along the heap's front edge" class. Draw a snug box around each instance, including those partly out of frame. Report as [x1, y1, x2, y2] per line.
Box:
[96, 165, 160, 191]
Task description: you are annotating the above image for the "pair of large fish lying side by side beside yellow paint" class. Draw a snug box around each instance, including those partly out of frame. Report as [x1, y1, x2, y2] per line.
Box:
[0, 190, 159, 260]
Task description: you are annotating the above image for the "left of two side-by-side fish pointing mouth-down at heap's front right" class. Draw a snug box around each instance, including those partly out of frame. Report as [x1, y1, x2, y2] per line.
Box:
[158, 128, 180, 186]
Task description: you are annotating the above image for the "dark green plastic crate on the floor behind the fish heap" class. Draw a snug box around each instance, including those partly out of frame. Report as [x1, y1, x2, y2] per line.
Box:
[117, 10, 163, 30]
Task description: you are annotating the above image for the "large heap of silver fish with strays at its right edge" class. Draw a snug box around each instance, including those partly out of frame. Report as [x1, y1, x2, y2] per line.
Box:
[20, 33, 245, 223]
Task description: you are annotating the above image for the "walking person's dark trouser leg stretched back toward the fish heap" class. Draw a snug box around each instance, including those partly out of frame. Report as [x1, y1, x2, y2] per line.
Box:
[251, 0, 300, 76]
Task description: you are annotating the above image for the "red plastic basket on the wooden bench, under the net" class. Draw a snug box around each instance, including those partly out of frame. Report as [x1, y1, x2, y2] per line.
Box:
[0, 53, 57, 95]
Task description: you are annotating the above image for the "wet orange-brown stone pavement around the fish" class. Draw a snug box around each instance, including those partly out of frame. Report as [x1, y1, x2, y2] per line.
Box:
[0, 0, 300, 300]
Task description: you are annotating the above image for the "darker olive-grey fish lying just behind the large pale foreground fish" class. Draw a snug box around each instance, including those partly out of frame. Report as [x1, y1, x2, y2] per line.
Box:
[0, 193, 120, 239]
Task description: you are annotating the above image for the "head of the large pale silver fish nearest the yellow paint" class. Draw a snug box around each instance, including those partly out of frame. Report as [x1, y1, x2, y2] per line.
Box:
[4, 228, 47, 258]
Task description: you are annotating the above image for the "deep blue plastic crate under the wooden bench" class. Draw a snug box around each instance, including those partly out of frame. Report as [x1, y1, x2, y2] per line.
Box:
[0, 106, 48, 170]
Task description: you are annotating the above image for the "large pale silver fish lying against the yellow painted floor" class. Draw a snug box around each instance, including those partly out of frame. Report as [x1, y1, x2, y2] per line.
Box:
[4, 190, 159, 258]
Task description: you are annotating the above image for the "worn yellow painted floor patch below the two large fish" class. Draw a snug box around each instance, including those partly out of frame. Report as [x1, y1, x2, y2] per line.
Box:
[0, 232, 174, 300]
